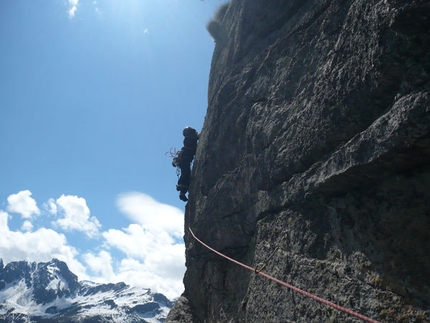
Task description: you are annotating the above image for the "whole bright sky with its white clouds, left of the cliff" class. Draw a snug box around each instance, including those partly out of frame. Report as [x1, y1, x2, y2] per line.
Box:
[0, 0, 222, 297]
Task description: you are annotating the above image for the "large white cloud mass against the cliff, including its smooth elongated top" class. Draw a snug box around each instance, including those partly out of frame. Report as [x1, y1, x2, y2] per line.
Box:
[85, 192, 185, 298]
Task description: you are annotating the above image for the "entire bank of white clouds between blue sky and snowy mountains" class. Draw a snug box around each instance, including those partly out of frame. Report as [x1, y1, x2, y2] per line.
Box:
[0, 190, 185, 298]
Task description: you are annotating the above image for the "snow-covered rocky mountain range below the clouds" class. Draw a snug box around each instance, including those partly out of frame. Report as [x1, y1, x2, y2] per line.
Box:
[0, 259, 173, 323]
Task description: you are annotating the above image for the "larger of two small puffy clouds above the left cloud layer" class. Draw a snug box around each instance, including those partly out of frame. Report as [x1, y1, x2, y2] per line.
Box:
[55, 194, 100, 237]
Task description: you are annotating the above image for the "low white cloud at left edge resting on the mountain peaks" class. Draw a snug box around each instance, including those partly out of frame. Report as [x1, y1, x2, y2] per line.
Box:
[0, 210, 88, 279]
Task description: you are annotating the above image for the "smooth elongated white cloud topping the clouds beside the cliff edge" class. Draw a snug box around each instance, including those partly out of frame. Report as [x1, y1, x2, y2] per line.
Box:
[117, 192, 184, 238]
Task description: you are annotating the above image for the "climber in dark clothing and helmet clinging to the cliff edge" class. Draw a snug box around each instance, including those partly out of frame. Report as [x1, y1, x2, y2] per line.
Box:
[172, 127, 199, 202]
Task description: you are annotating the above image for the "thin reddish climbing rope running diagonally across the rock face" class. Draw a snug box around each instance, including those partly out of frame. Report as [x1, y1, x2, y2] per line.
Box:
[188, 228, 379, 323]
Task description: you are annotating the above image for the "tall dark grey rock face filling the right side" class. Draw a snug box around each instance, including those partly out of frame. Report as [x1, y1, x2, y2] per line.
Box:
[166, 0, 430, 323]
